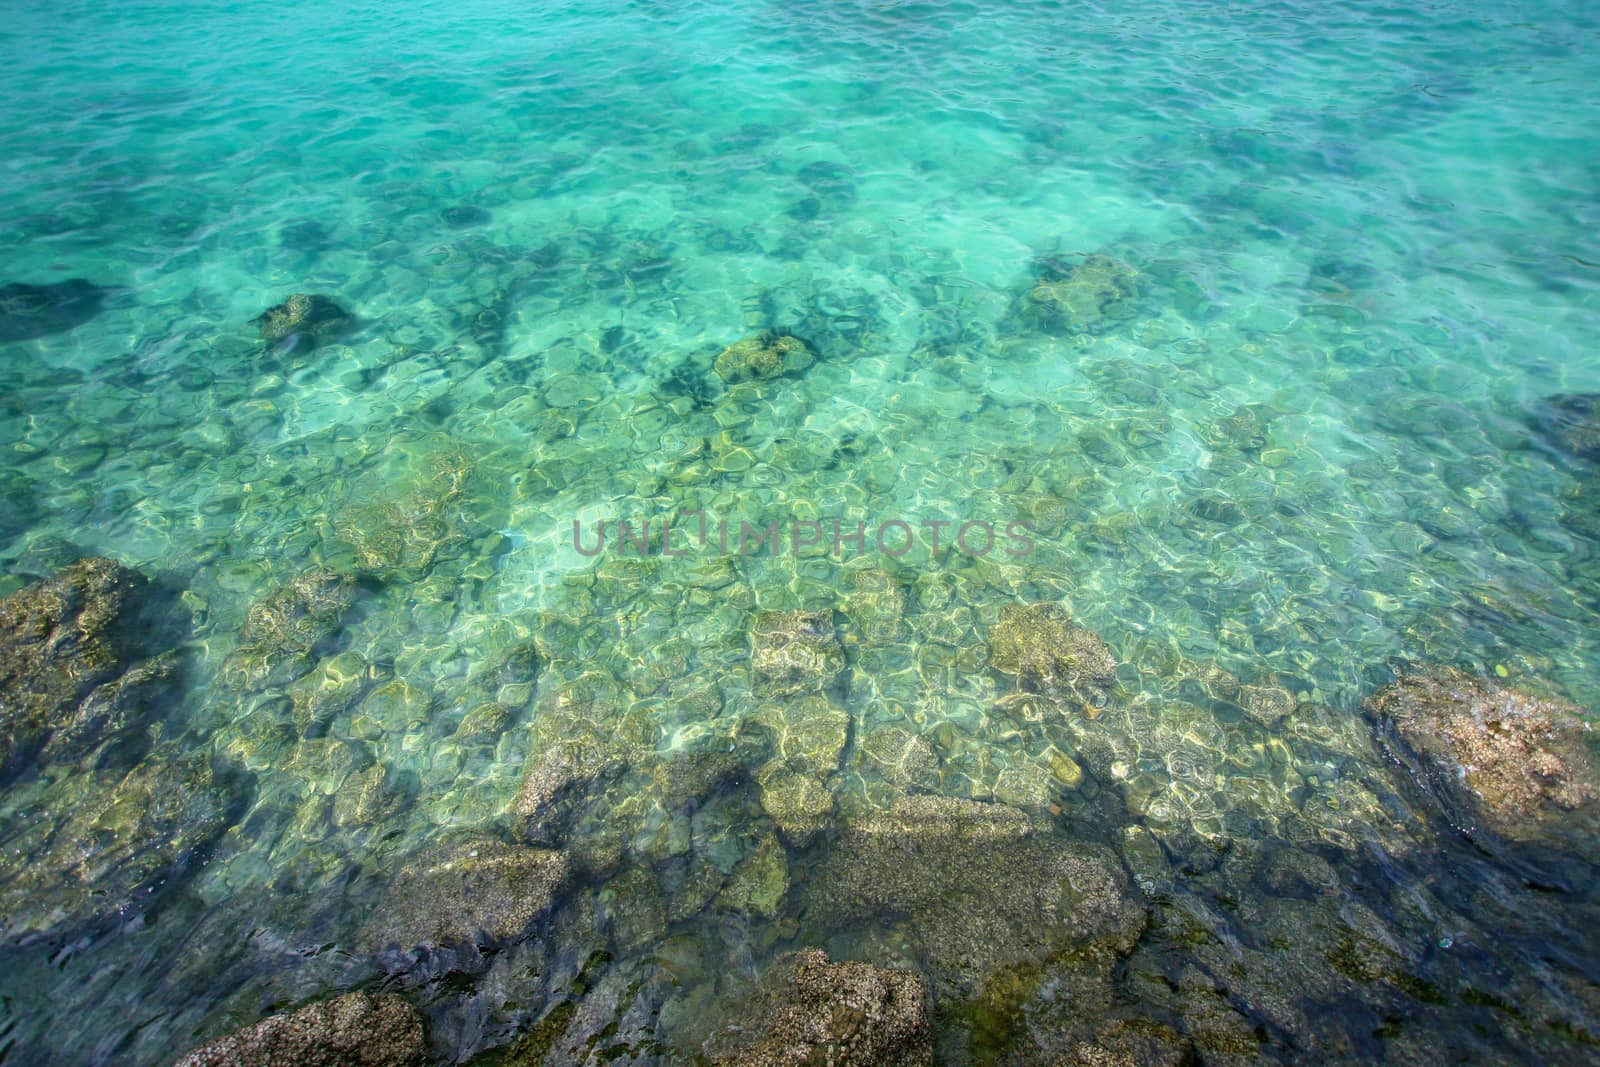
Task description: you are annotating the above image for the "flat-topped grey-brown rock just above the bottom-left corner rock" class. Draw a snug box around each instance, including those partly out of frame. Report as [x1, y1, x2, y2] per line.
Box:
[357, 837, 570, 969]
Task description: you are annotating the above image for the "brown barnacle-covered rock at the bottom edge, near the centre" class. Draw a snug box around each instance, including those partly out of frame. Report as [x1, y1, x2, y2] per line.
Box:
[702, 949, 933, 1067]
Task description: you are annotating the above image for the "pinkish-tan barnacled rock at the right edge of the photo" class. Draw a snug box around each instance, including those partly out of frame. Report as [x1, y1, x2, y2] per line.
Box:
[1366, 667, 1600, 838]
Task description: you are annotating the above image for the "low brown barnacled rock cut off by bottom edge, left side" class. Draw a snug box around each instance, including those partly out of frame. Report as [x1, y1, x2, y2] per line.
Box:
[176, 993, 427, 1067]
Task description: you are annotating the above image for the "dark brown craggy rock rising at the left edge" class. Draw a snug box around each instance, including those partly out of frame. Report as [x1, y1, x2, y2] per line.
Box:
[0, 558, 146, 774]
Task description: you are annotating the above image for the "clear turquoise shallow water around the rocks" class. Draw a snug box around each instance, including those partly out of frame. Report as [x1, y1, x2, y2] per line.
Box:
[0, 3, 1600, 1062]
